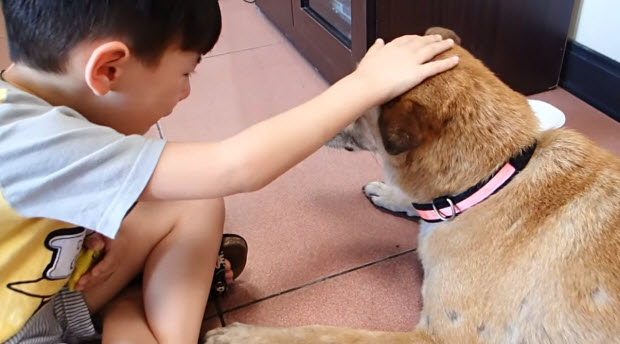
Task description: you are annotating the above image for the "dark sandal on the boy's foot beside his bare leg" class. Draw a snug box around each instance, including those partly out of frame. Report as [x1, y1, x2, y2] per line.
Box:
[211, 234, 248, 295]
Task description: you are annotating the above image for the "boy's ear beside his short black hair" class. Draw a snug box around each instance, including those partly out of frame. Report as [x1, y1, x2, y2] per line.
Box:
[84, 41, 130, 96]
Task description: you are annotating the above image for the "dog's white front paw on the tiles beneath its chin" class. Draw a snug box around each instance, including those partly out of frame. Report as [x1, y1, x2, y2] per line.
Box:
[363, 182, 418, 217]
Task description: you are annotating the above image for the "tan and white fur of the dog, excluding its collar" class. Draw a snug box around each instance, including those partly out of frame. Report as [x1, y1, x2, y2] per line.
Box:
[207, 28, 620, 344]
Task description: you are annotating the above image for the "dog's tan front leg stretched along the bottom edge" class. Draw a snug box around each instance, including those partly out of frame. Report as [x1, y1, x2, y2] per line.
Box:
[205, 323, 438, 344]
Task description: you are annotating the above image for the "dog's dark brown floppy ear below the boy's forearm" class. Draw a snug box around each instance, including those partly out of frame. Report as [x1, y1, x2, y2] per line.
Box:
[379, 97, 423, 155]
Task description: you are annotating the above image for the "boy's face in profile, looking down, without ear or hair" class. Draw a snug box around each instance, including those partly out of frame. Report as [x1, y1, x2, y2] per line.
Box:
[105, 48, 200, 134]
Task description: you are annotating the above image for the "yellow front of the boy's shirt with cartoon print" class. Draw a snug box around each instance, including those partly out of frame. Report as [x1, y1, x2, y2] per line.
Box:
[0, 189, 86, 343]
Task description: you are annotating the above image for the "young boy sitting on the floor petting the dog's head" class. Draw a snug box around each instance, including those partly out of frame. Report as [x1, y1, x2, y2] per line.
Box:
[0, 0, 457, 343]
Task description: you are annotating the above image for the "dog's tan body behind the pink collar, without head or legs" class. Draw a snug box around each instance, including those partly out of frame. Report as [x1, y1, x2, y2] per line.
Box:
[419, 125, 620, 343]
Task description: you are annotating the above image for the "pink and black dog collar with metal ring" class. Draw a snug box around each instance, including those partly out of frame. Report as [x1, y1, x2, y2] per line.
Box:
[413, 142, 536, 222]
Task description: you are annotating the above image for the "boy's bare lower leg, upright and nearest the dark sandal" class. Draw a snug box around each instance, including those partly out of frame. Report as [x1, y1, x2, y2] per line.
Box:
[143, 200, 224, 343]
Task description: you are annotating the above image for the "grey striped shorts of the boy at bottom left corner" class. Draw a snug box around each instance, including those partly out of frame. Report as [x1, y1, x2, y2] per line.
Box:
[4, 288, 99, 344]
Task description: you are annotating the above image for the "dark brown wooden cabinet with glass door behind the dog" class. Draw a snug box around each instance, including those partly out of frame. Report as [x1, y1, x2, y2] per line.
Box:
[256, 0, 574, 94]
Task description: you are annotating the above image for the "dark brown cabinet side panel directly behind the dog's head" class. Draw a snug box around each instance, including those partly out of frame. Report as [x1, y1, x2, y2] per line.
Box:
[376, 0, 574, 94]
